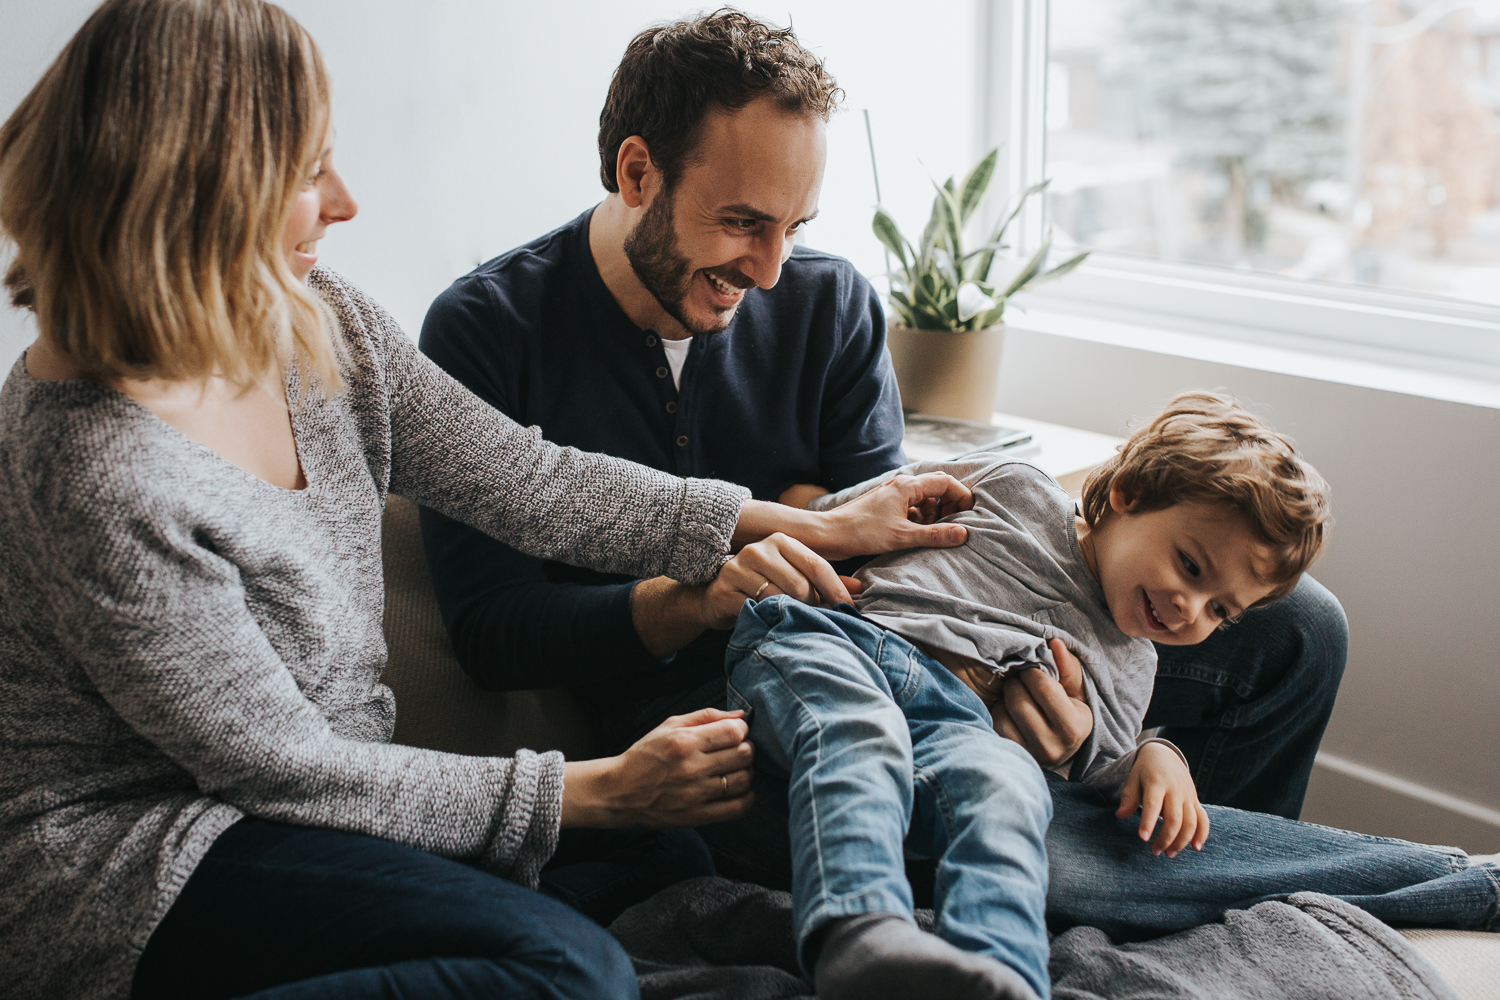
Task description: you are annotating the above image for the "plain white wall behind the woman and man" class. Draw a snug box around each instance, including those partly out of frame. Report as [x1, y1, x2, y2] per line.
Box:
[0, 0, 978, 364]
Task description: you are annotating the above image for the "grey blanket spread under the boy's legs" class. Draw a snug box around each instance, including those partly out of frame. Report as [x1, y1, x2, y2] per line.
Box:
[609, 879, 1458, 1000]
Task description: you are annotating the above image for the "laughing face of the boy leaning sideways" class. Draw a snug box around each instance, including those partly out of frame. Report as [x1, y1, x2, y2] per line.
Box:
[1083, 487, 1275, 646]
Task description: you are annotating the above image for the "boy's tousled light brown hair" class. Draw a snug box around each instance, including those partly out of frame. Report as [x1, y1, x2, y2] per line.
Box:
[1083, 391, 1332, 607]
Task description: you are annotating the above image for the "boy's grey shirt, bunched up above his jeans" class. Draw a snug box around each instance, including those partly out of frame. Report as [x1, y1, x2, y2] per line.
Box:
[815, 453, 1157, 796]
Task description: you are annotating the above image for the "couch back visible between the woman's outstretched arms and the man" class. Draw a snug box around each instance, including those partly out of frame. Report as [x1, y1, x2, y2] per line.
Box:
[381, 496, 594, 760]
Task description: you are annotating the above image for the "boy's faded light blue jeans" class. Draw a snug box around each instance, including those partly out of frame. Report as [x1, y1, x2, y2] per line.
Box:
[726, 597, 1052, 997]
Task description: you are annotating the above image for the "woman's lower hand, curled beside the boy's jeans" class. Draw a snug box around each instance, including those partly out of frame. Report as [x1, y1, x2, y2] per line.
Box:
[563, 708, 755, 829]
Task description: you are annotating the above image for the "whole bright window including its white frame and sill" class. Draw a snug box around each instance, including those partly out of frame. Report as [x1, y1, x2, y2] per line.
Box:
[984, 0, 1500, 378]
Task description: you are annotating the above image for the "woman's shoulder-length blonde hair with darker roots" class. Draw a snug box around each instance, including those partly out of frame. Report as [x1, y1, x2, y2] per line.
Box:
[0, 0, 339, 390]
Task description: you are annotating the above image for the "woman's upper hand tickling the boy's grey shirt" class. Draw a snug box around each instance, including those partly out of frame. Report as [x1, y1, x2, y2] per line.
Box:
[818, 472, 974, 559]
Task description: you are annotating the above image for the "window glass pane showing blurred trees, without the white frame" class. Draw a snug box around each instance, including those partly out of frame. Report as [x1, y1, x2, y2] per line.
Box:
[1047, 0, 1500, 303]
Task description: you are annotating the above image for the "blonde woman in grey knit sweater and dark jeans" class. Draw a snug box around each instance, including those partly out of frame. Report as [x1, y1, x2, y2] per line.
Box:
[0, 0, 966, 1000]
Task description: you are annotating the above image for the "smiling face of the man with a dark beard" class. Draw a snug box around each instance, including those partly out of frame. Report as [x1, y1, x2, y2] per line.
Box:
[624, 97, 828, 334]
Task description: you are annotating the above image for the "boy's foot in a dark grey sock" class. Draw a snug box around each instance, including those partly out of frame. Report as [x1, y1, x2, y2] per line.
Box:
[813, 913, 1038, 1000]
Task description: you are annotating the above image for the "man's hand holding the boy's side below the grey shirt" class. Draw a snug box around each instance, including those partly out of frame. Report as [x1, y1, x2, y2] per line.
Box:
[990, 639, 1094, 768]
